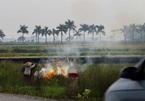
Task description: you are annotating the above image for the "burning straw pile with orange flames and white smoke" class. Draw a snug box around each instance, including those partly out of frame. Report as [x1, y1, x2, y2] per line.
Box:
[34, 58, 72, 83]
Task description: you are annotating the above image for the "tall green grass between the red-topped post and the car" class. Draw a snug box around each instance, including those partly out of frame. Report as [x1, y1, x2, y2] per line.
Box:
[79, 64, 134, 101]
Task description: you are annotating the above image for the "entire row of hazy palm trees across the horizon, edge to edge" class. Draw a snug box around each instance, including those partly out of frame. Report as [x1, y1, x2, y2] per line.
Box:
[0, 20, 145, 43]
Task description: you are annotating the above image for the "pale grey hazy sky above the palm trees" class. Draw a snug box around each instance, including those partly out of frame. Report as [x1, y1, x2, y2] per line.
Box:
[0, 0, 145, 37]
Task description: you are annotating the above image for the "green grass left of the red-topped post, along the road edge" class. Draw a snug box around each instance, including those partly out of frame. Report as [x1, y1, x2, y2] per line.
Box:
[0, 61, 67, 99]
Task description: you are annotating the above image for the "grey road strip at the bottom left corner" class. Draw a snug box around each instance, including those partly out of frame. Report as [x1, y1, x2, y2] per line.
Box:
[0, 93, 76, 101]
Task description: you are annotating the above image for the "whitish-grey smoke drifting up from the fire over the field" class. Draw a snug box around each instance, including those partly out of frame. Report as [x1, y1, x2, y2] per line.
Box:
[34, 40, 98, 77]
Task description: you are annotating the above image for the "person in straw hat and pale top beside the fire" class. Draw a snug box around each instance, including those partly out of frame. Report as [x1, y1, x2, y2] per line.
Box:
[22, 62, 35, 80]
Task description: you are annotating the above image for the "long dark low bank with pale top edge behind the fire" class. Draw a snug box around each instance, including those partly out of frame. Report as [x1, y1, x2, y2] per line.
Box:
[0, 55, 145, 63]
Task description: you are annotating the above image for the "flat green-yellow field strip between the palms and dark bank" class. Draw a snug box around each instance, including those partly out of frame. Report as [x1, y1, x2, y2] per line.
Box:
[0, 43, 145, 57]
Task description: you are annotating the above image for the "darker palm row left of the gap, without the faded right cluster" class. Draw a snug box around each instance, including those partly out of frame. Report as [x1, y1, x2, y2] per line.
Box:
[0, 20, 105, 43]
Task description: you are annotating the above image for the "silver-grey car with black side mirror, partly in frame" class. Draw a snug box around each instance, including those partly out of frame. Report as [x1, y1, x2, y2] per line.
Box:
[105, 58, 145, 101]
